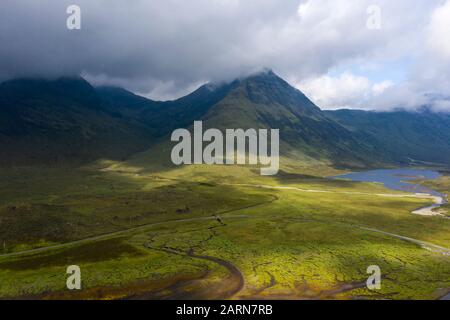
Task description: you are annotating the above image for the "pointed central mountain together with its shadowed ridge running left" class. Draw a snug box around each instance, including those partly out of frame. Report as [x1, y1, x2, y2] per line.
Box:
[99, 70, 381, 166]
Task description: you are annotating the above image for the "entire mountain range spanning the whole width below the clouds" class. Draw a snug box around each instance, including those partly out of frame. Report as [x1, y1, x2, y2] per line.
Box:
[0, 71, 450, 167]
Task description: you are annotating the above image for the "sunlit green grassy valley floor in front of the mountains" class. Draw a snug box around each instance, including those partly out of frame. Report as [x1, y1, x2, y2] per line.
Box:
[0, 158, 450, 299]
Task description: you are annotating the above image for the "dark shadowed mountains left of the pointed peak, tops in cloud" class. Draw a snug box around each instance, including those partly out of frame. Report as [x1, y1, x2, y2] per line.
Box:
[0, 77, 239, 166]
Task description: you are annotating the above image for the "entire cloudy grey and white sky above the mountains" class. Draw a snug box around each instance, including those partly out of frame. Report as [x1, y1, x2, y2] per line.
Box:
[0, 0, 450, 111]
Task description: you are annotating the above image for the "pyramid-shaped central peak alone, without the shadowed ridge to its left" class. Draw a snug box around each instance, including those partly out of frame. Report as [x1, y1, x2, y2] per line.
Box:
[193, 71, 384, 166]
